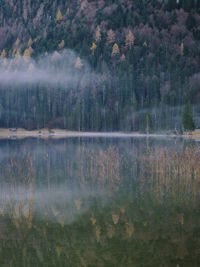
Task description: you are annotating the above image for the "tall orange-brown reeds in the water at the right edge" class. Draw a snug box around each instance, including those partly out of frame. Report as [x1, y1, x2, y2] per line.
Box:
[136, 146, 200, 200]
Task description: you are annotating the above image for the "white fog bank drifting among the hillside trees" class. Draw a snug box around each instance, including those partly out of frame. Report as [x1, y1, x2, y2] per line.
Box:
[0, 50, 100, 88]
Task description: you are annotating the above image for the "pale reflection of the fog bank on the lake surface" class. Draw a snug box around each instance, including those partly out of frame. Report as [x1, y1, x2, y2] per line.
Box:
[0, 183, 108, 224]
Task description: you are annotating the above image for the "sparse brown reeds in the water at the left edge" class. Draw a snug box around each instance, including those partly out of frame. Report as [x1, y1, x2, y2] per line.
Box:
[0, 154, 35, 227]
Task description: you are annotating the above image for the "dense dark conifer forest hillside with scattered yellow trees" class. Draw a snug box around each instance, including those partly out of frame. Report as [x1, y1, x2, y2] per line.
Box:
[0, 0, 200, 131]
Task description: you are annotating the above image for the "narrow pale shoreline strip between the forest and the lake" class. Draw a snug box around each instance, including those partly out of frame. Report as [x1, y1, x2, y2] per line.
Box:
[0, 128, 200, 140]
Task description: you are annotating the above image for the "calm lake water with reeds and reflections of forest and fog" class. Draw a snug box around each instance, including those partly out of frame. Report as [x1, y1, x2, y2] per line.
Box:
[0, 137, 200, 267]
